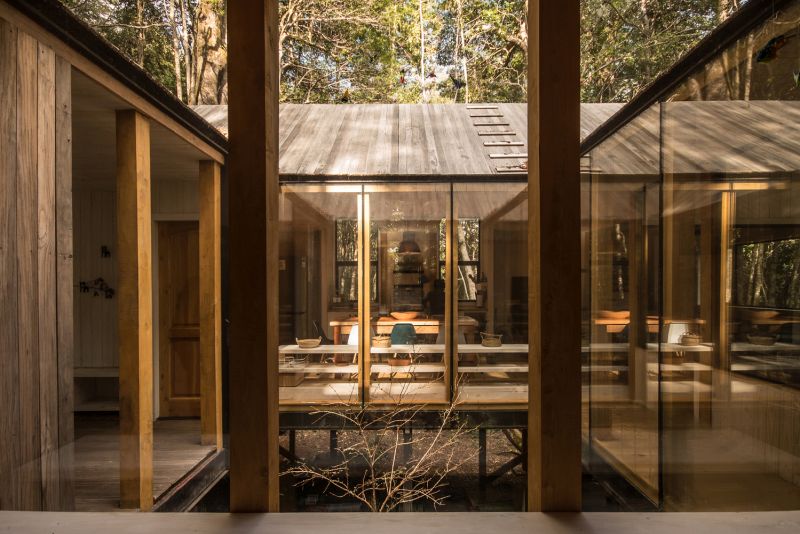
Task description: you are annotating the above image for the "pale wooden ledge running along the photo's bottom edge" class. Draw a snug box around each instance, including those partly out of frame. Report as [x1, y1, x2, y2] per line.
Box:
[0, 512, 800, 534]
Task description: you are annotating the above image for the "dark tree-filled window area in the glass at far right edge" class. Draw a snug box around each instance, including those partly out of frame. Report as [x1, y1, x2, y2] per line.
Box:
[735, 239, 800, 309]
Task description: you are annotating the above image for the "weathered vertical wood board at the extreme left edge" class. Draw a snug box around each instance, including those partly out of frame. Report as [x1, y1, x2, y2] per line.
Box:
[0, 15, 20, 510]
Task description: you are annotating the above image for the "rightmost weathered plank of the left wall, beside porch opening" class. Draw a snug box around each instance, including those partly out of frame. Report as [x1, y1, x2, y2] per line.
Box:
[55, 57, 75, 510]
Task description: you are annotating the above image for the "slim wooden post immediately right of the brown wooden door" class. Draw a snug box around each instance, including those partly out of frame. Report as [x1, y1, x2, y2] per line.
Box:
[199, 161, 222, 450]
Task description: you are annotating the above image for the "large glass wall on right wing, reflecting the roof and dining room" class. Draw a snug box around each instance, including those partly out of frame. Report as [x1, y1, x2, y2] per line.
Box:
[583, 4, 800, 511]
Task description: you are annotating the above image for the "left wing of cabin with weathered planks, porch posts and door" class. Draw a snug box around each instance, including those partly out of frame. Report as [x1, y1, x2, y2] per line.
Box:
[0, 2, 227, 510]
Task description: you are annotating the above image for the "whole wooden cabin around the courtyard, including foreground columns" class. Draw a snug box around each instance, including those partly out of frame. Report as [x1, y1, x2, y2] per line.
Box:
[0, 0, 800, 524]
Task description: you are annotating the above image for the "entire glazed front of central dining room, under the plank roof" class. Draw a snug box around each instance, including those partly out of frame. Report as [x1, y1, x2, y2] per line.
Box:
[279, 183, 528, 409]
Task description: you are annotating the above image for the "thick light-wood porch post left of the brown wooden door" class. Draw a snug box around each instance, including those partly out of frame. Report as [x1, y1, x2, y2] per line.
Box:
[117, 110, 153, 510]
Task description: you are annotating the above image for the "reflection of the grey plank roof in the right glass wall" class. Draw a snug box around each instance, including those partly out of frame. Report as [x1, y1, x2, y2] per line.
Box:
[588, 100, 800, 178]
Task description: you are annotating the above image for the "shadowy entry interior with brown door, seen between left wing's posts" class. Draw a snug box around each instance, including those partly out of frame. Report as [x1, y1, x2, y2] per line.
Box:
[71, 69, 216, 511]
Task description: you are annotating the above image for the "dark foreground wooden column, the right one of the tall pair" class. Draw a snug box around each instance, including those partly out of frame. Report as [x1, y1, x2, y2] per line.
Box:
[528, 0, 581, 512]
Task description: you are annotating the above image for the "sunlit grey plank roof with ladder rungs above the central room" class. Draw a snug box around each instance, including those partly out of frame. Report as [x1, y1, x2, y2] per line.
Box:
[195, 104, 621, 179]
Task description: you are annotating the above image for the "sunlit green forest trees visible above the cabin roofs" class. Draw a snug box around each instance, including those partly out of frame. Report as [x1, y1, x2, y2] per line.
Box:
[63, 0, 739, 104]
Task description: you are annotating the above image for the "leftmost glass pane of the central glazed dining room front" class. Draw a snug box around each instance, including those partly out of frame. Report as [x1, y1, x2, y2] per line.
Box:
[279, 185, 360, 406]
